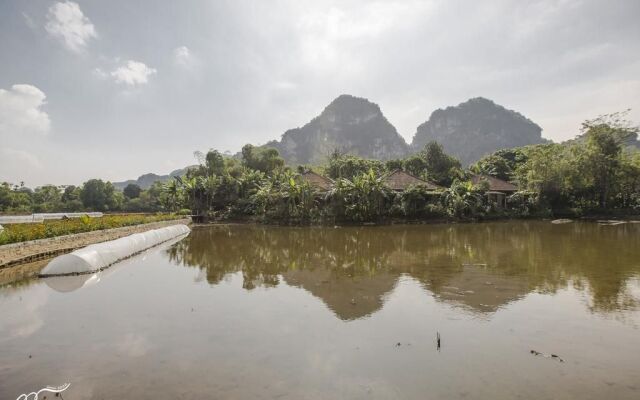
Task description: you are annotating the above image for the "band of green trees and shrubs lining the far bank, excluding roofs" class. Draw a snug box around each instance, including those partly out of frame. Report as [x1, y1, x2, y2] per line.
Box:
[0, 113, 640, 224]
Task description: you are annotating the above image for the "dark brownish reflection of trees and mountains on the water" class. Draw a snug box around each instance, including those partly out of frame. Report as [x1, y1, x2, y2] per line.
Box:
[168, 222, 640, 320]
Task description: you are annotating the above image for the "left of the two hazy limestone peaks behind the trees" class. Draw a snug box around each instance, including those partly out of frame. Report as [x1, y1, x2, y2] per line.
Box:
[267, 95, 408, 164]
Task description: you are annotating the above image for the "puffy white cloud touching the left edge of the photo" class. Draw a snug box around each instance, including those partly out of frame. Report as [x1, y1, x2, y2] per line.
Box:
[0, 85, 51, 137]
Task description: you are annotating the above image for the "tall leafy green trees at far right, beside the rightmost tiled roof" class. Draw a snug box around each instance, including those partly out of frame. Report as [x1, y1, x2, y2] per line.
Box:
[472, 114, 640, 215]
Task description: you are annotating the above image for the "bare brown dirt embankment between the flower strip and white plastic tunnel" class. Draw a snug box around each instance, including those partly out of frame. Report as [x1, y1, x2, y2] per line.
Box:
[0, 219, 191, 269]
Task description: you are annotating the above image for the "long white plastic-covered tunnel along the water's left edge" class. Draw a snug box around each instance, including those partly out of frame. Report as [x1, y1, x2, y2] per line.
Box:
[40, 224, 190, 276]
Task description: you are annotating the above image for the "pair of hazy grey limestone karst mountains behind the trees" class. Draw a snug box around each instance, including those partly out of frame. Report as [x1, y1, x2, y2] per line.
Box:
[267, 95, 546, 165]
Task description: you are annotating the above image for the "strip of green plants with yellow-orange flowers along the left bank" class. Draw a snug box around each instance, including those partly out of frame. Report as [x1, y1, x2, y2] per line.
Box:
[0, 214, 184, 245]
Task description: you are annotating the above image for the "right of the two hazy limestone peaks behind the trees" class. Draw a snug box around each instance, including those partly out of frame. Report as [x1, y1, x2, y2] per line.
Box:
[411, 97, 546, 165]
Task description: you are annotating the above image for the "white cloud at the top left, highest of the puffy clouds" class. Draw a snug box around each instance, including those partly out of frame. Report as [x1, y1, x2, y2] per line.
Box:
[45, 1, 98, 53]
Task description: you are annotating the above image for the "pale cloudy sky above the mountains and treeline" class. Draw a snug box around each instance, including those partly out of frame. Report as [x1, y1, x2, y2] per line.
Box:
[0, 0, 640, 187]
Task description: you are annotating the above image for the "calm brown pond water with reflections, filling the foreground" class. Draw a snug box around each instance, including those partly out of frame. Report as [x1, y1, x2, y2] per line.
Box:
[0, 222, 640, 400]
